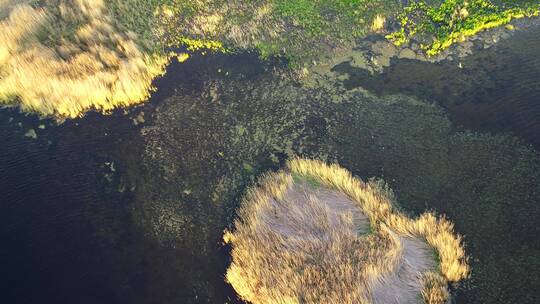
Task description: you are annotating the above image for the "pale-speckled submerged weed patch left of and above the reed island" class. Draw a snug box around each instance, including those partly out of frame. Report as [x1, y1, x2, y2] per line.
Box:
[137, 62, 308, 250]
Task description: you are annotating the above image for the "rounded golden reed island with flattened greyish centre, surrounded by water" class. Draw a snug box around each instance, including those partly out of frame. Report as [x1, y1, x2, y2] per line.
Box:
[224, 159, 469, 304]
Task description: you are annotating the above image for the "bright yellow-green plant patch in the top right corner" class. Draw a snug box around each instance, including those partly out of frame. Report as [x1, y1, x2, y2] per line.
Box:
[387, 0, 540, 56]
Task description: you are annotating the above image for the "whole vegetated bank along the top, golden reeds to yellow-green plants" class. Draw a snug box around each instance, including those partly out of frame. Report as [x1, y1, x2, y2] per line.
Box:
[0, 0, 540, 119]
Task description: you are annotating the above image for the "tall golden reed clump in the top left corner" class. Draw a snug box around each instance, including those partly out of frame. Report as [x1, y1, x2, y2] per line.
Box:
[0, 0, 168, 119]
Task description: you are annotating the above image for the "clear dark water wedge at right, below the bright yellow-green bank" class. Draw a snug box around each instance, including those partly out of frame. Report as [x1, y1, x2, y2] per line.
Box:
[334, 27, 540, 149]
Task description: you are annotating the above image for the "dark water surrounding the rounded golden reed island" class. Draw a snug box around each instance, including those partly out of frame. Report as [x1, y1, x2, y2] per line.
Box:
[0, 24, 540, 303]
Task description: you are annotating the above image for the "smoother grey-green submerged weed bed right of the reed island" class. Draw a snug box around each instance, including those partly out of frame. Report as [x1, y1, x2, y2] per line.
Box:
[325, 89, 540, 304]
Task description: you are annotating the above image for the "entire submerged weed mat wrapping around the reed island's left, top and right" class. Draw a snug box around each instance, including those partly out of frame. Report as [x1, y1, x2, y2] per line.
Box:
[134, 54, 540, 303]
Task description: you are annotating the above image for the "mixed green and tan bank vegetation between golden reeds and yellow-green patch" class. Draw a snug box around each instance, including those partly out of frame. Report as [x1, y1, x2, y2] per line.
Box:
[154, 0, 399, 64]
